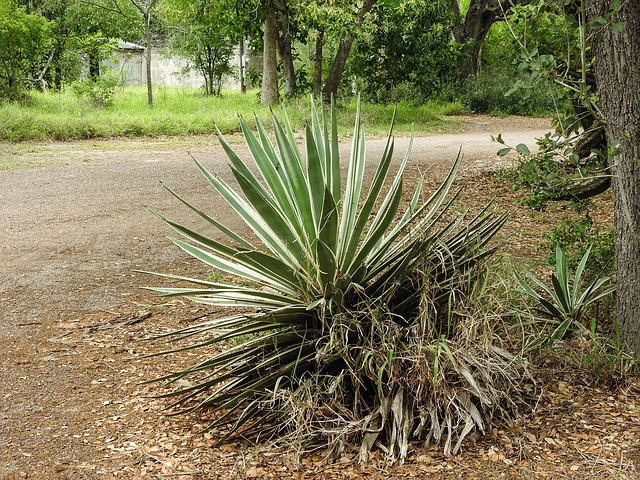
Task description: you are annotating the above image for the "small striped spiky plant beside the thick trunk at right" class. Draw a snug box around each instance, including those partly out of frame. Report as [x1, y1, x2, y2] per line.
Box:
[516, 245, 616, 342]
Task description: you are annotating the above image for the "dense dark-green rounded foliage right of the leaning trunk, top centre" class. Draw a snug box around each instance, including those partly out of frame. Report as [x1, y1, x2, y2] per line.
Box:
[351, 0, 460, 103]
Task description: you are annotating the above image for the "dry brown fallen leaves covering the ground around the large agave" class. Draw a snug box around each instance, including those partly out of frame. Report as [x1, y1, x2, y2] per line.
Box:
[0, 159, 640, 480]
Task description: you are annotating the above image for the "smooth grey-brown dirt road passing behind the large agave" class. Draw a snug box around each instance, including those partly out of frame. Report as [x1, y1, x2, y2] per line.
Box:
[0, 117, 549, 328]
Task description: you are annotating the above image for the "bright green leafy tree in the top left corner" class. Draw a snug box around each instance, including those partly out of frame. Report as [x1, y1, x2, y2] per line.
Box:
[0, 0, 54, 98]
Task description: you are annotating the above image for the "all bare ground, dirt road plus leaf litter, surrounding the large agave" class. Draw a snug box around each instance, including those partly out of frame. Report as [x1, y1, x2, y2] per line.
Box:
[0, 116, 640, 480]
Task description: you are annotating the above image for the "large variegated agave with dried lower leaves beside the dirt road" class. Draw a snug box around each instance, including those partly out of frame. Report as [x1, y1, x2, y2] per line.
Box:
[141, 97, 513, 458]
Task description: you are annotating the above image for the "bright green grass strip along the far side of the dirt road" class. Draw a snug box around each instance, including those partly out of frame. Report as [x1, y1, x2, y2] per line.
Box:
[0, 87, 464, 142]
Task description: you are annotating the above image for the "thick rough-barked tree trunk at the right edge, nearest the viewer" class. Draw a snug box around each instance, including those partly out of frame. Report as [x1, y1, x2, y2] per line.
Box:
[586, 0, 640, 358]
